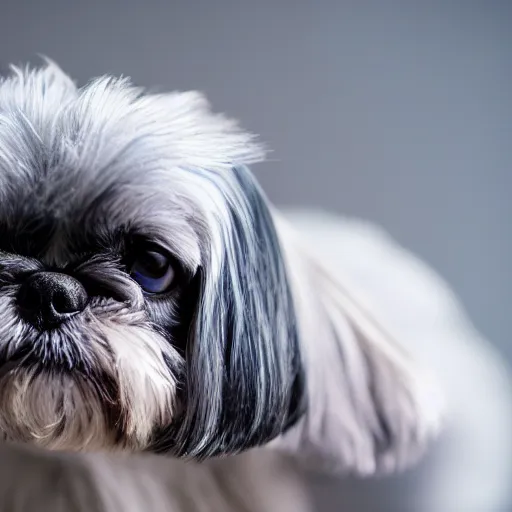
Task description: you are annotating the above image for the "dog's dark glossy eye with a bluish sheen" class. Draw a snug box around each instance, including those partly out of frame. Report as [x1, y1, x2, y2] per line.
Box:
[130, 247, 174, 293]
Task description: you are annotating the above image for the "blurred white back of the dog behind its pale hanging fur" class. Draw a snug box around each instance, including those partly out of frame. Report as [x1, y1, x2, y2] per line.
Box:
[286, 210, 512, 512]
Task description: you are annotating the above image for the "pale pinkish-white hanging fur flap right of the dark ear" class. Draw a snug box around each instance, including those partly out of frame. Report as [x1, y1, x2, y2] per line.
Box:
[268, 212, 442, 474]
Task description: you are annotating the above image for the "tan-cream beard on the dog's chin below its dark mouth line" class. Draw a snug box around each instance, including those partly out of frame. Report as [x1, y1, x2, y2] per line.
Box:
[0, 358, 126, 451]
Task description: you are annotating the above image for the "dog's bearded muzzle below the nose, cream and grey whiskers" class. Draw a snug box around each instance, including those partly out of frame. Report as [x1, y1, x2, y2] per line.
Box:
[0, 303, 183, 451]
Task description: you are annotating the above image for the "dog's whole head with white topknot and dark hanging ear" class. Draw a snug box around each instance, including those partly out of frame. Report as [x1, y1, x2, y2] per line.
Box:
[0, 64, 302, 457]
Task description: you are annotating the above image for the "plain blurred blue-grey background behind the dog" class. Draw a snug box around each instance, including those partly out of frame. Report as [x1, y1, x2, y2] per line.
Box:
[0, 0, 512, 512]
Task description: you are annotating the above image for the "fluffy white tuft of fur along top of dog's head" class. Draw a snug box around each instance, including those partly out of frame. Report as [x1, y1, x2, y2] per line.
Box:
[0, 61, 264, 197]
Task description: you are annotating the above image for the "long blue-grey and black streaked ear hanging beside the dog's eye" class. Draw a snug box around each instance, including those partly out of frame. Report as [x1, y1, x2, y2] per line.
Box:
[170, 166, 303, 458]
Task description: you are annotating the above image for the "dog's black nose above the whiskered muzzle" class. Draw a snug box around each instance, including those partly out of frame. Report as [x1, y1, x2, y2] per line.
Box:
[18, 272, 88, 328]
